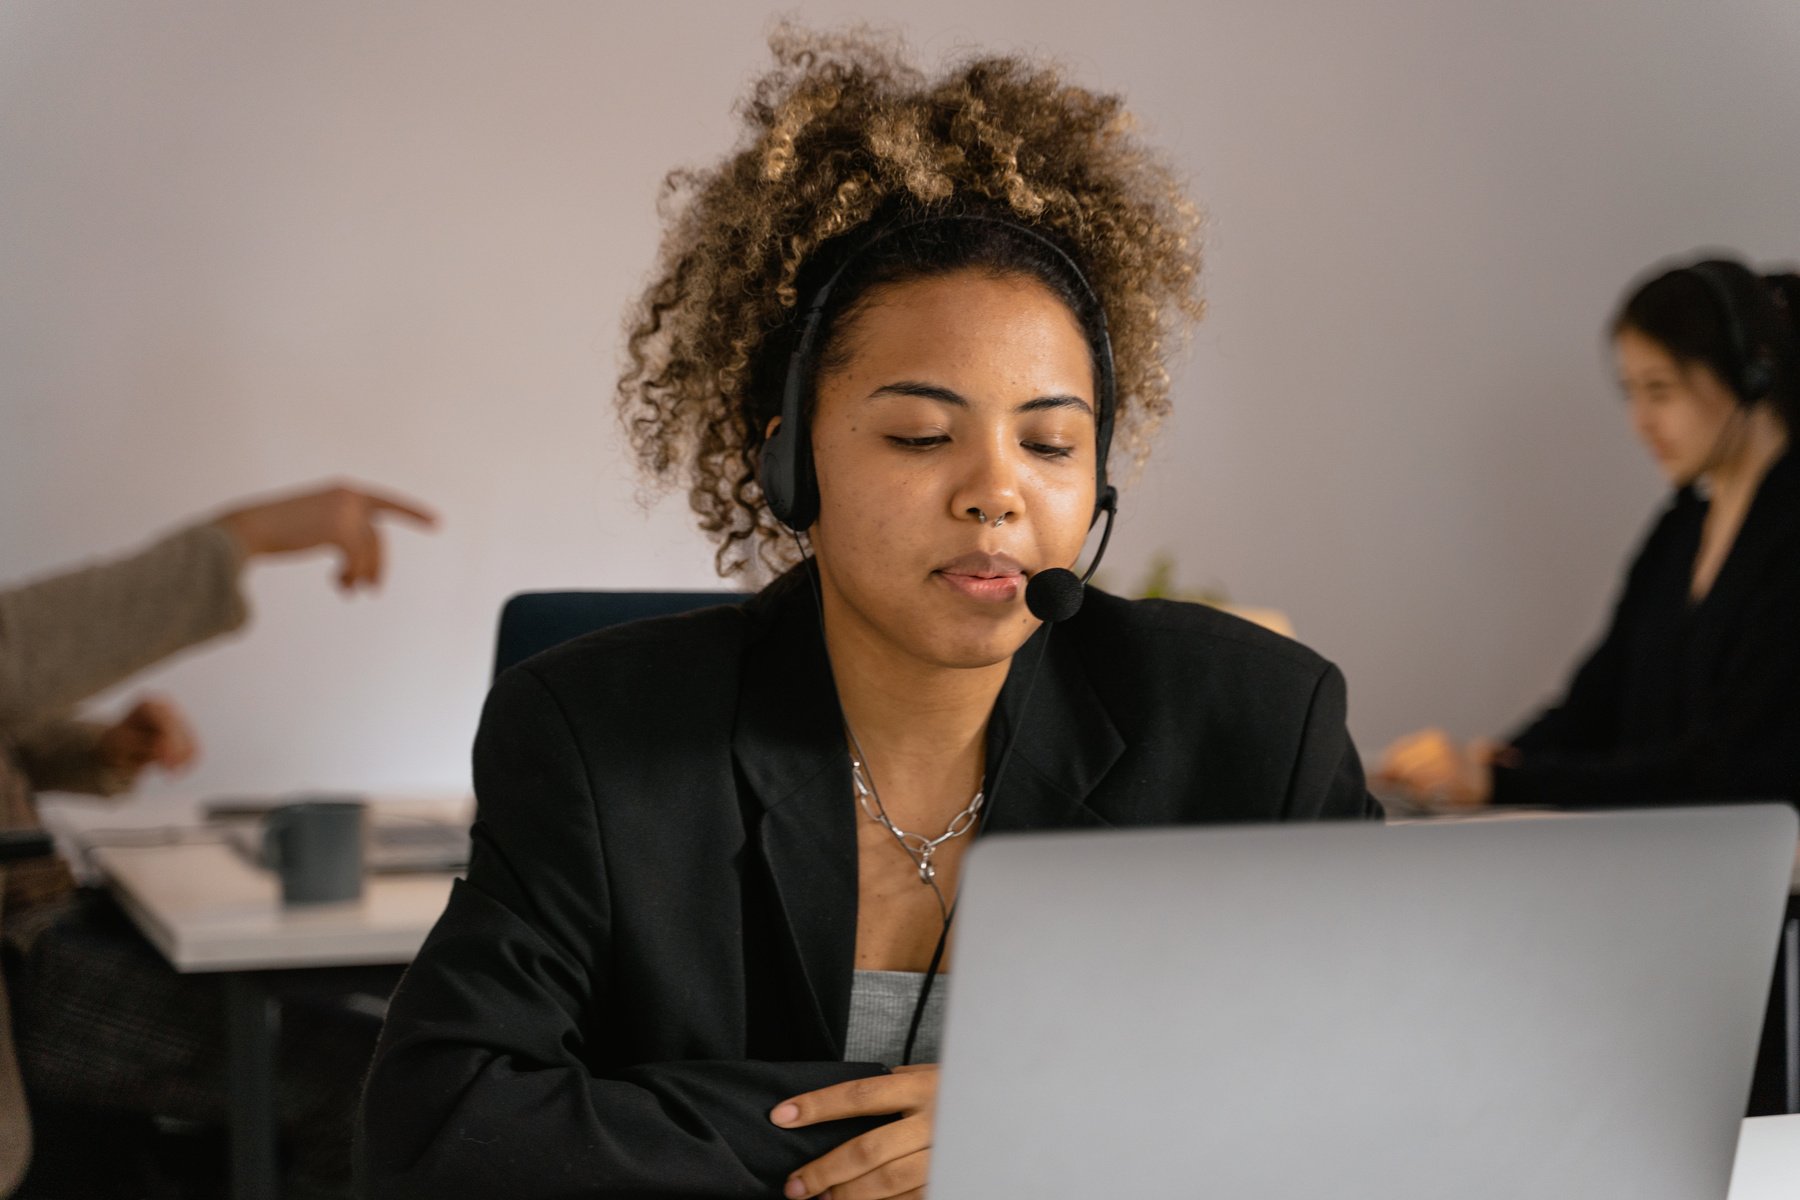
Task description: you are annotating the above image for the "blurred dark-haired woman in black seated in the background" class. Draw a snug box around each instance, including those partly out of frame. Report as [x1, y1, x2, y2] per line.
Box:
[1375, 259, 1800, 808]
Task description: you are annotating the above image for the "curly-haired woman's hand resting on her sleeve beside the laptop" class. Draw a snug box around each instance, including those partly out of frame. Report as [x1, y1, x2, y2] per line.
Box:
[769, 1063, 938, 1200]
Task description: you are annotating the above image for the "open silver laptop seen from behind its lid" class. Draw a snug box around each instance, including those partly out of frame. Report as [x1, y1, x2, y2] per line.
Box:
[931, 806, 1796, 1200]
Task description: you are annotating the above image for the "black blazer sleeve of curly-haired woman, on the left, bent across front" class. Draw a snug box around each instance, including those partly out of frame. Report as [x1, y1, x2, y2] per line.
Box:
[356, 669, 884, 1200]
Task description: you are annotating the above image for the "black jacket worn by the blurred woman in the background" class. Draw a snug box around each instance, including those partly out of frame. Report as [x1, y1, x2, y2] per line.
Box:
[1494, 453, 1800, 808]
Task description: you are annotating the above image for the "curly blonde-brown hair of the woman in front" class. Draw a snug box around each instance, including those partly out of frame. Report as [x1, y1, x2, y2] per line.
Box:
[617, 25, 1202, 576]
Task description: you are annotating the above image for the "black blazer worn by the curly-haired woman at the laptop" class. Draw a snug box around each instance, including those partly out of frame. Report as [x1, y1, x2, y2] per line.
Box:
[358, 572, 1373, 1200]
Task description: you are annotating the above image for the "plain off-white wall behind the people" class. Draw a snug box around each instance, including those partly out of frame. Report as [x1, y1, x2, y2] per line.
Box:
[0, 0, 1800, 793]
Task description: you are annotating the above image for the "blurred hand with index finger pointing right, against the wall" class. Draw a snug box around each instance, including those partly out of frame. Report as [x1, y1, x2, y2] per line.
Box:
[218, 484, 437, 592]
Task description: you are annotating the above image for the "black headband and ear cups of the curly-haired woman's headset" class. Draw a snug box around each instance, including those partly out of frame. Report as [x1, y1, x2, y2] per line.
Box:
[756, 212, 1118, 533]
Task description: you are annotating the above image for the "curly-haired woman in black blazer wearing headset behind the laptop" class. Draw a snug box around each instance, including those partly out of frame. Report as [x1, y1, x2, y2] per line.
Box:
[362, 31, 1370, 1200]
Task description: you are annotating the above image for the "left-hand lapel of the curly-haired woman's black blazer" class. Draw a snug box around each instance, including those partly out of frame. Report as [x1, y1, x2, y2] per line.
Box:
[733, 574, 857, 1056]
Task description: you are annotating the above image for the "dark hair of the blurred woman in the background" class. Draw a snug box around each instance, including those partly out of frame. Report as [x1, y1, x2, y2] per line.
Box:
[1611, 257, 1800, 434]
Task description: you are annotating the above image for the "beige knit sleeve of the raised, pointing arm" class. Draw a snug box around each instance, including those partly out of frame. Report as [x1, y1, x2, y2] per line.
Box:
[0, 525, 248, 732]
